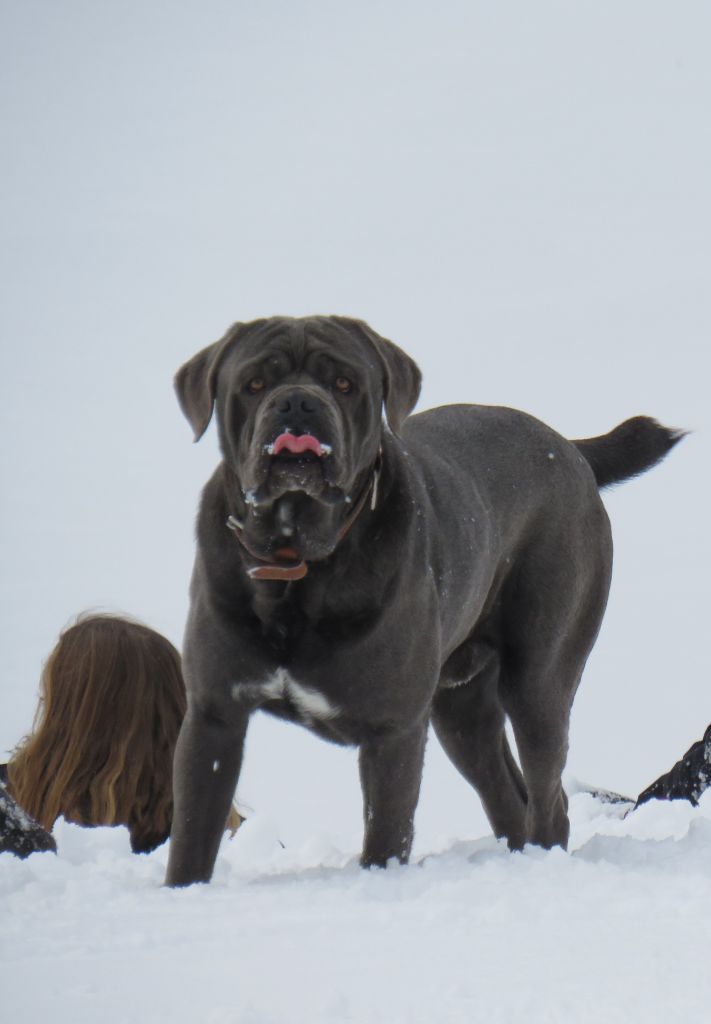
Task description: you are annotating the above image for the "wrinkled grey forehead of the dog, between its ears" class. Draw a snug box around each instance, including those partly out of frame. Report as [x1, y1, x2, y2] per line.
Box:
[235, 316, 380, 373]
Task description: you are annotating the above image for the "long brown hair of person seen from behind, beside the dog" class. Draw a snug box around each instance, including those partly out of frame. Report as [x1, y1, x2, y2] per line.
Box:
[7, 615, 240, 853]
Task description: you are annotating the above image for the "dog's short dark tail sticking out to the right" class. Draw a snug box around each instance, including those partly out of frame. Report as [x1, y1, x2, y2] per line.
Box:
[573, 416, 686, 487]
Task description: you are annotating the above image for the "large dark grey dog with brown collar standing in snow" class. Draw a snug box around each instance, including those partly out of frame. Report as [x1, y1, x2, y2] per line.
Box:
[167, 316, 681, 886]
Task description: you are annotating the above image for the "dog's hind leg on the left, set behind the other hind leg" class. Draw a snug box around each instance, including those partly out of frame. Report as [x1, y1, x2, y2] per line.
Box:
[432, 650, 527, 848]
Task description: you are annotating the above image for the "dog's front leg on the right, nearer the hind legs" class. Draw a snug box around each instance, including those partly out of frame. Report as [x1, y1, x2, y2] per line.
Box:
[360, 722, 427, 867]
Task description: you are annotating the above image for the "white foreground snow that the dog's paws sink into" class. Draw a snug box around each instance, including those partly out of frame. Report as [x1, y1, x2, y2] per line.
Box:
[5, 791, 711, 1024]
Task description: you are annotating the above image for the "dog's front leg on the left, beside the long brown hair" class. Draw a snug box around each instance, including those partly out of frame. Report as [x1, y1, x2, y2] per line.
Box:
[166, 706, 249, 886]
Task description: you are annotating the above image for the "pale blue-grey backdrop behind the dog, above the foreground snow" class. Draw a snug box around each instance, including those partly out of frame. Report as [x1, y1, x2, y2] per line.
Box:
[0, 0, 711, 847]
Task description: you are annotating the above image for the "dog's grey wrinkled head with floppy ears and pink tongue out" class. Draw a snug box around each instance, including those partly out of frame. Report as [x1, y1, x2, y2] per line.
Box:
[175, 316, 420, 560]
